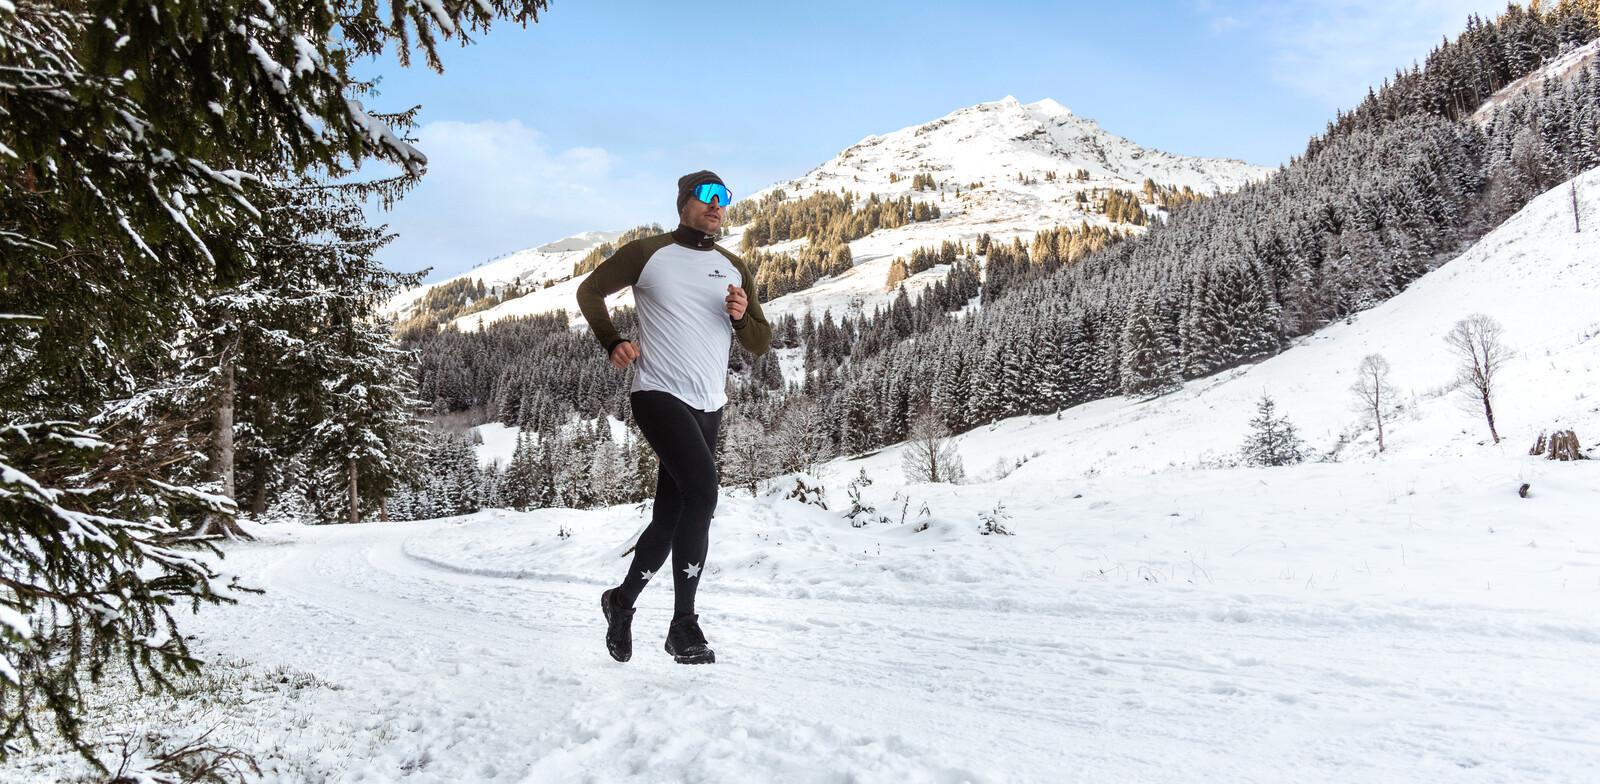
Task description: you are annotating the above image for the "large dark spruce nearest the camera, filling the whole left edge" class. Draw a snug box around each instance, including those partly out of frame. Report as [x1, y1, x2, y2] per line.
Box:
[0, 0, 544, 766]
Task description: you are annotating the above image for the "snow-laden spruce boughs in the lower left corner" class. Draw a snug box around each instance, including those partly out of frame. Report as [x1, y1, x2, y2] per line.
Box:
[0, 422, 237, 765]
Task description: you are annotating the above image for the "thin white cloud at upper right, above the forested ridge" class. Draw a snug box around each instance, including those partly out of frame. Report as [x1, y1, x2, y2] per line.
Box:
[1194, 0, 1506, 109]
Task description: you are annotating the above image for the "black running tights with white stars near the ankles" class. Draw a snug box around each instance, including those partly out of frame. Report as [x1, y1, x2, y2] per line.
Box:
[616, 390, 722, 619]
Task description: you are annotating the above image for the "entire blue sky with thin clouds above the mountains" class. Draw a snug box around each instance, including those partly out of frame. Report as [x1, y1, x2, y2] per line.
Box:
[358, 0, 1504, 280]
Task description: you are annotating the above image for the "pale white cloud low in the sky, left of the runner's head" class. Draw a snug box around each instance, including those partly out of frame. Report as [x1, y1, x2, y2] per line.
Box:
[373, 120, 674, 278]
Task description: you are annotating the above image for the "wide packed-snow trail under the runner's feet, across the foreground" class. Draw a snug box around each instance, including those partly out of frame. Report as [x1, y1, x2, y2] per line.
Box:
[190, 512, 1600, 782]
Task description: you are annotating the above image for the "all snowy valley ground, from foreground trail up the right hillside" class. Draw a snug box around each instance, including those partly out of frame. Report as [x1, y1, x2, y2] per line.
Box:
[0, 182, 1600, 784]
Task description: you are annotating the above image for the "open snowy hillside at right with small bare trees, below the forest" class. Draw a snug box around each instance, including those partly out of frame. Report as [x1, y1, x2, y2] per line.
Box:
[850, 170, 1600, 483]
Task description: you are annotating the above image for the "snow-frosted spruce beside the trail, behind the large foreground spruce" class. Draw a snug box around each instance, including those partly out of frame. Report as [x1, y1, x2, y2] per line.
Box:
[200, 170, 422, 533]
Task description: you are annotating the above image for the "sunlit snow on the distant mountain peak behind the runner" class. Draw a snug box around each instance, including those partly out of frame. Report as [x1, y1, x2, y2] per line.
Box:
[392, 96, 1272, 330]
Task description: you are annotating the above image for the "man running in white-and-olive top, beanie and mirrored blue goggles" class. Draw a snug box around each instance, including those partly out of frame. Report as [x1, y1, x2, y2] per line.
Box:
[578, 171, 773, 664]
